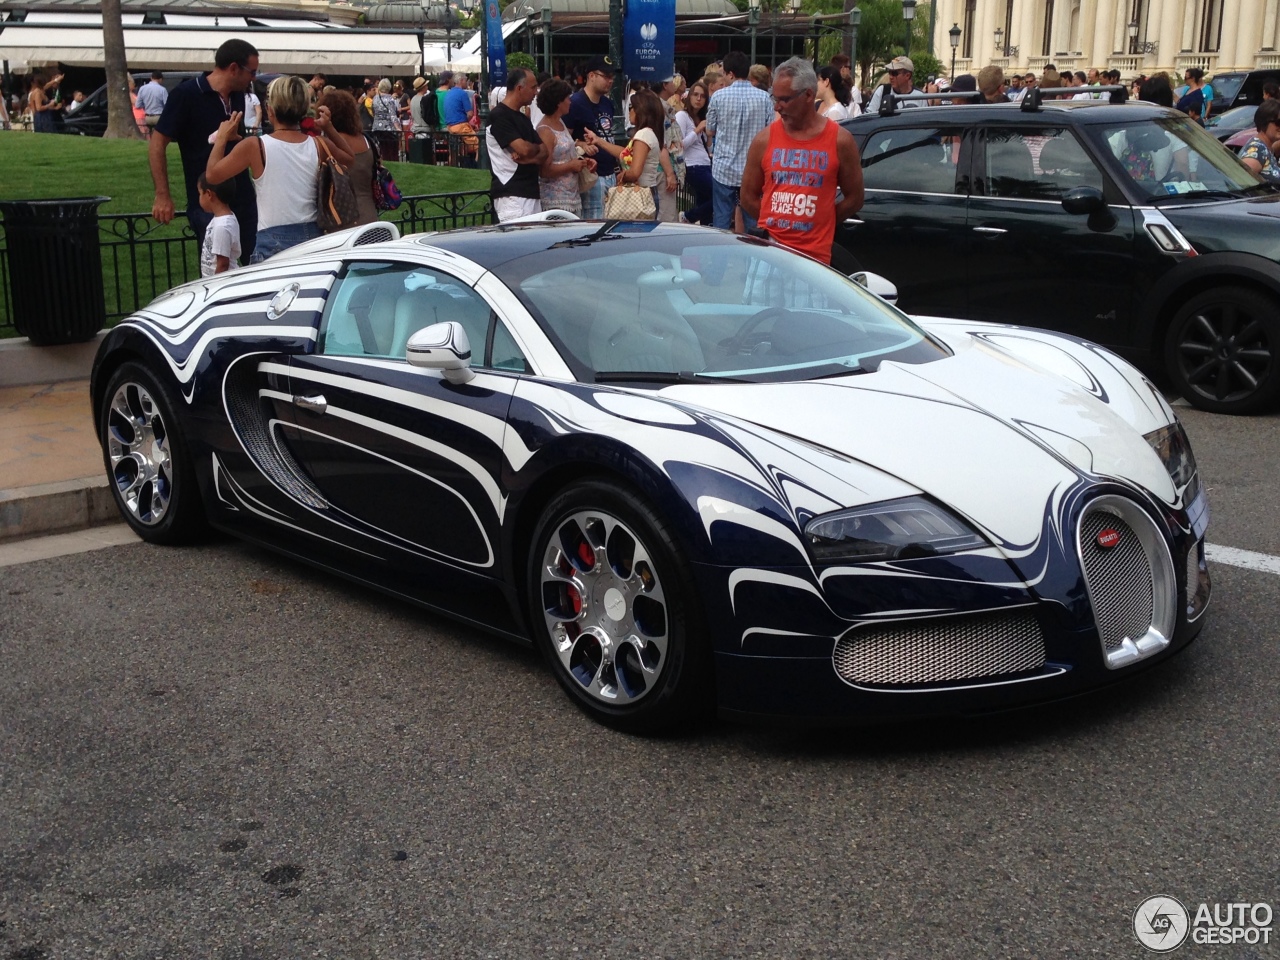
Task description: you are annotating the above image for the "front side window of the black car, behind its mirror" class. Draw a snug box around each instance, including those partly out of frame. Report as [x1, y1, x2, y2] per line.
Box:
[984, 128, 1102, 200]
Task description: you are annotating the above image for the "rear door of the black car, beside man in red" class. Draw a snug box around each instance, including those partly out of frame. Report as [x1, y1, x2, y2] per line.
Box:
[836, 122, 968, 316]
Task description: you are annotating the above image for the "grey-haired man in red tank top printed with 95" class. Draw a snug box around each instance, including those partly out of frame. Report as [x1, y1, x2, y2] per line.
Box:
[740, 58, 863, 264]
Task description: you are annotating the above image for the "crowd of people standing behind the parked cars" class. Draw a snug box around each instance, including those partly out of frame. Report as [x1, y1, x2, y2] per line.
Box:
[0, 40, 1280, 273]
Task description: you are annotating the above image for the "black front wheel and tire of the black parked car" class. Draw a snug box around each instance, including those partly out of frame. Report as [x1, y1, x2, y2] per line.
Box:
[1165, 287, 1280, 415]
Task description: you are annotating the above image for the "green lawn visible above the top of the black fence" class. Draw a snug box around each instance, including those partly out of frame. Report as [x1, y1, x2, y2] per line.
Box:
[0, 131, 489, 214]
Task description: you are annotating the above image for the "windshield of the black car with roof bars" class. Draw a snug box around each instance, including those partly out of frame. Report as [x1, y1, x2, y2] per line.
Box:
[1098, 114, 1262, 198]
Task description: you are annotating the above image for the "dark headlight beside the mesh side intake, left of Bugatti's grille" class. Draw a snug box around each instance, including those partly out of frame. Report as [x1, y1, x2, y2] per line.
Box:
[804, 497, 987, 562]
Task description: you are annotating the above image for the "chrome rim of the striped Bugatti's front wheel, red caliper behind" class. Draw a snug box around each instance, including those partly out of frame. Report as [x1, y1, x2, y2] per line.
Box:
[541, 511, 669, 707]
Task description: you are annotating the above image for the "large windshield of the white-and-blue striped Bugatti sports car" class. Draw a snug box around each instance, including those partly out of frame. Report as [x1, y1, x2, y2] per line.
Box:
[499, 230, 947, 384]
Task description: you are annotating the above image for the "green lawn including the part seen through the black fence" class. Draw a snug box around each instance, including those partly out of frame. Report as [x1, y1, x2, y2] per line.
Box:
[0, 131, 489, 338]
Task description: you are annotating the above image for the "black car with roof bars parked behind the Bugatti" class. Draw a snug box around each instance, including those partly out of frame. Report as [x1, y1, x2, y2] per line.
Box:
[836, 99, 1280, 413]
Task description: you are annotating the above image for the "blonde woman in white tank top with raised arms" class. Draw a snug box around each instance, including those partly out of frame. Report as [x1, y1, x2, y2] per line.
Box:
[205, 77, 352, 264]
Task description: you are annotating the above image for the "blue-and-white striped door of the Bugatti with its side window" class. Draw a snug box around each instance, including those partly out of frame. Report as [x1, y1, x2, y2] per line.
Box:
[282, 260, 526, 620]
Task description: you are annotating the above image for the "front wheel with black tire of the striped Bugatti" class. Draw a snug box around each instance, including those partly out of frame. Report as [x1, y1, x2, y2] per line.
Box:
[529, 480, 714, 735]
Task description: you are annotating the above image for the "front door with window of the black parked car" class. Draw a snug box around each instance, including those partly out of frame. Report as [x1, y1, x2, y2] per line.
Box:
[963, 123, 1135, 344]
